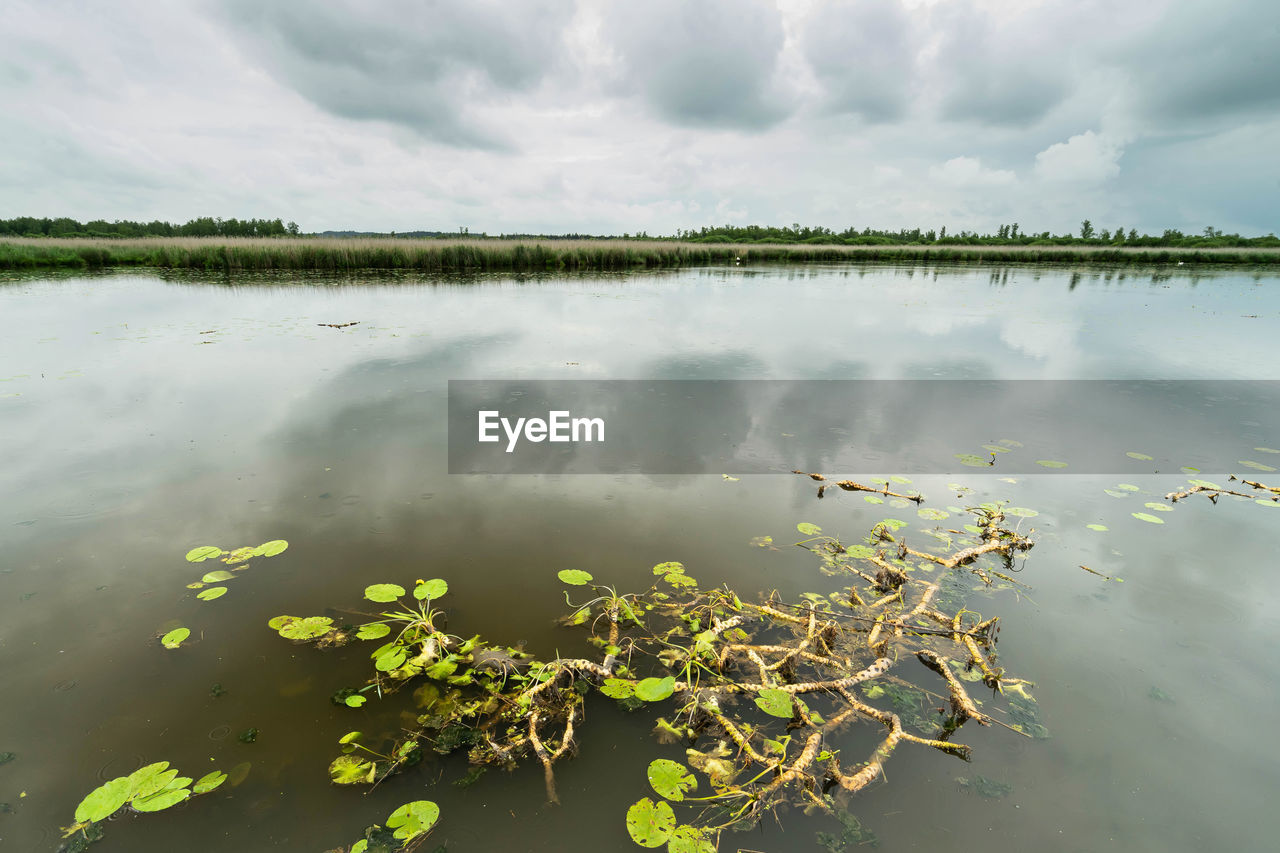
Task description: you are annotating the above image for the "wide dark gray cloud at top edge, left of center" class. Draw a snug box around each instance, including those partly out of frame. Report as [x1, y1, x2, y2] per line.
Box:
[223, 0, 573, 149]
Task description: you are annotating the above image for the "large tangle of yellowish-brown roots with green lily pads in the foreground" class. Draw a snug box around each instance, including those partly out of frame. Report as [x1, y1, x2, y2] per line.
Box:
[269, 475, 1043, 853]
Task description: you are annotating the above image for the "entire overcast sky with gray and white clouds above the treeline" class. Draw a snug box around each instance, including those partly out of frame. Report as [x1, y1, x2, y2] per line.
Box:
[0, 0, 1280, 234]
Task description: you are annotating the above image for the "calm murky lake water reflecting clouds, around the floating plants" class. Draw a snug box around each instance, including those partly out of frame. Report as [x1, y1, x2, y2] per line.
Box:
[0, 266, 1280, 853]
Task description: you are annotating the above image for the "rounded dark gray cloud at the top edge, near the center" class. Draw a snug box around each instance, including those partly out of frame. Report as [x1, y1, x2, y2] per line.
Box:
[604, 0, 788, 129]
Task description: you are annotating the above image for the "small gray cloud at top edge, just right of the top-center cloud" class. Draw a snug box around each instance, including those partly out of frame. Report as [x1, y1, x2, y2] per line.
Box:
[803, 0, 919, 122]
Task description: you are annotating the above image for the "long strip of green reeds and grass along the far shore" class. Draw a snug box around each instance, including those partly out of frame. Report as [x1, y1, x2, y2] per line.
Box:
[0, 237, 1280, 273]
